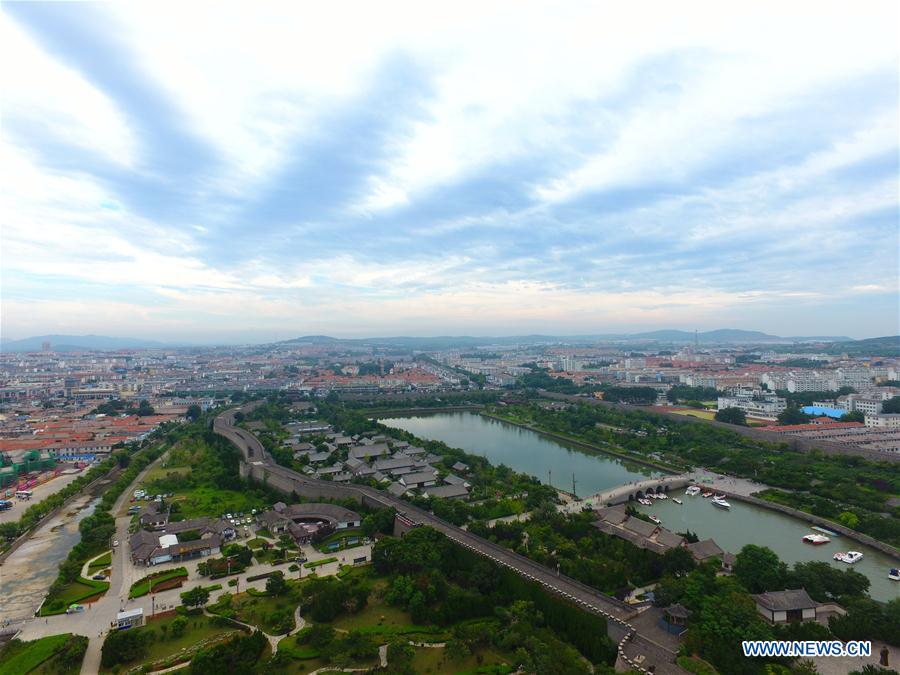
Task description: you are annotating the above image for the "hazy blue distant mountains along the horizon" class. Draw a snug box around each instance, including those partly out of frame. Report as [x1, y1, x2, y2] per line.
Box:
[0, 328, 884, 355]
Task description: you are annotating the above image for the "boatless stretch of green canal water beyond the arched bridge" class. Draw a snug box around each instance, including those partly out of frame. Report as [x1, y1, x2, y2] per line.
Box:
[379, 412, 662, 496]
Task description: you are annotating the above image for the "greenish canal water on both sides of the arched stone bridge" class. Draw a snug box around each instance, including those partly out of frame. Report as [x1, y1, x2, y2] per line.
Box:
[380, 412, 900, 601]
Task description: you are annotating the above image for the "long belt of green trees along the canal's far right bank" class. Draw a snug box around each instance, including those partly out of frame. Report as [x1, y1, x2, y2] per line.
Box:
[490, 403, 900, 546]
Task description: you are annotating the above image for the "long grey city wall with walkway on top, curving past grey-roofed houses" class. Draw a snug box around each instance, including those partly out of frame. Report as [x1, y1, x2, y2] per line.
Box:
[213, 406, 685, 674]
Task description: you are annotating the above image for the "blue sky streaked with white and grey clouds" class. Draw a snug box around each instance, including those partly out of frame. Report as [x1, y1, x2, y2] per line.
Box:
[0, 0, 900, 342]
